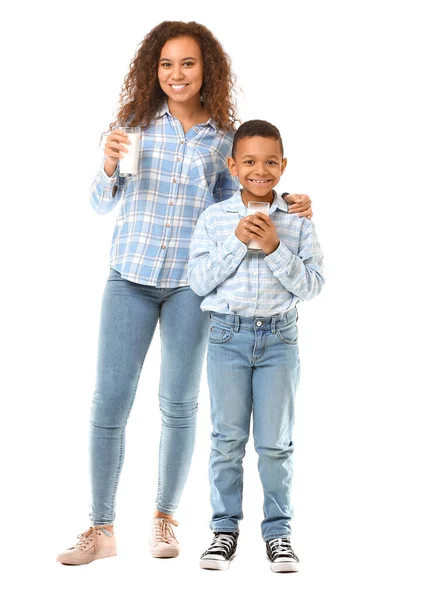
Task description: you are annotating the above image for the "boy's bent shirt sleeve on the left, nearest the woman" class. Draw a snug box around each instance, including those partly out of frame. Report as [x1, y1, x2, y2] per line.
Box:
[188, 211, 247, 296]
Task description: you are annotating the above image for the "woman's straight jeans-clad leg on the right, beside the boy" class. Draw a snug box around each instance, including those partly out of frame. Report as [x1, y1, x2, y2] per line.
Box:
[156, 287, 209, 515]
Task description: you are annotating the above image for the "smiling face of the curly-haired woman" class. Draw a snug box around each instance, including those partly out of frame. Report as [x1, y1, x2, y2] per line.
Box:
[158, 36, 203, 102]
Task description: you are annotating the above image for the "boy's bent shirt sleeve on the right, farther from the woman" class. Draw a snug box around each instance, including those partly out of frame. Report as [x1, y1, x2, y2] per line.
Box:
[265, 219, 325, 300]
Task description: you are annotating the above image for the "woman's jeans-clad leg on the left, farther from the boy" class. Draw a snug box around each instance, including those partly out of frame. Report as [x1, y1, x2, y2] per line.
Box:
[90, 271, 161, 525]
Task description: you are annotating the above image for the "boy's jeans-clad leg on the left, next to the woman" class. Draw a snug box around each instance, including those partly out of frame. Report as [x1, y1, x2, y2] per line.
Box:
[208, 315, 253, 532]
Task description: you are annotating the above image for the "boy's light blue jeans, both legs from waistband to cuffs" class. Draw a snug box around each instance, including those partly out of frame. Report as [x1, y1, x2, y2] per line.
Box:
[208, 308, 300, 541]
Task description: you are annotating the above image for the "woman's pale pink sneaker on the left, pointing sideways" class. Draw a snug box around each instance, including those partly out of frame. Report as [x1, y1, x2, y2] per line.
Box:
[57, 526, 117, 565]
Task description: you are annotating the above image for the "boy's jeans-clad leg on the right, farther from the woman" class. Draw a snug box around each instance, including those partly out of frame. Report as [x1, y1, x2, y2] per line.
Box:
[253, 310, 300, 541]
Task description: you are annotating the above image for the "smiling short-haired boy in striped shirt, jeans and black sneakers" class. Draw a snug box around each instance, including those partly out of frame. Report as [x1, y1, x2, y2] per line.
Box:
[189, 121, 324, 572]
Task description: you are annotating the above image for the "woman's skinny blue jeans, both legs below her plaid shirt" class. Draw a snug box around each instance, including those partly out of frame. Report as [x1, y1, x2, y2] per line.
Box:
[90, 270, 209, 525]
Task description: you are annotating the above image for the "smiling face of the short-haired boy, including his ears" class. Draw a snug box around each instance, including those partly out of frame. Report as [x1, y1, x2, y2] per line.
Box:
[228, 135, 287, 202]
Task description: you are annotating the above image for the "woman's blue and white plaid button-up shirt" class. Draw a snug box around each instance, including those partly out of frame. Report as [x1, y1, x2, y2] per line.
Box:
[91, 104, 239, 287]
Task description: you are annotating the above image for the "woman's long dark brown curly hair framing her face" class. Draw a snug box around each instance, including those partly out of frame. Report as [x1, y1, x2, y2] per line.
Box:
[110, 21, 238, 130]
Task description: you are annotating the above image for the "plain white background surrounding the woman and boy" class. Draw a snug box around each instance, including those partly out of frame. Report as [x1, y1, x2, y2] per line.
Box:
[0, 0, 421, 599]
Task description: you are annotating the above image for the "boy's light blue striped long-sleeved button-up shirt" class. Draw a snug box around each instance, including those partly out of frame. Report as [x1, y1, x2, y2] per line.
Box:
[189, 190, 324, 317]
